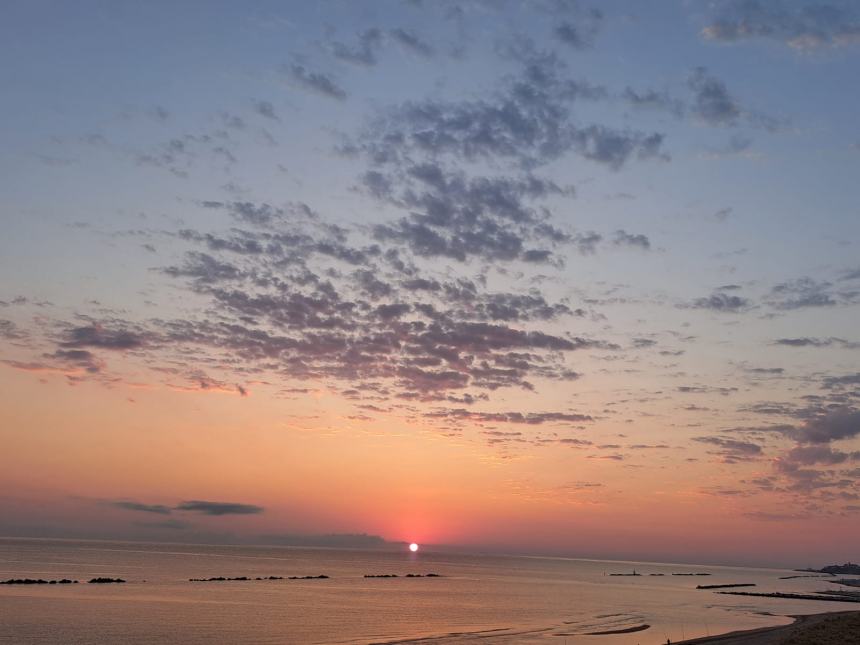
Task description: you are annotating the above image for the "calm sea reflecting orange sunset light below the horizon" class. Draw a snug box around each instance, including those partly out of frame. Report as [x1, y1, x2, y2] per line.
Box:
[0, 538, 855, 645]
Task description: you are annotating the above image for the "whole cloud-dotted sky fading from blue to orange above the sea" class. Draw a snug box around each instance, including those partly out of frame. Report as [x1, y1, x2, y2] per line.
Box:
[0, 0, 860, 566]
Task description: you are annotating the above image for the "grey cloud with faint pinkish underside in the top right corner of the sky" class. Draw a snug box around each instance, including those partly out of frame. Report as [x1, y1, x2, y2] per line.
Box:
[701, 0, 860, 50]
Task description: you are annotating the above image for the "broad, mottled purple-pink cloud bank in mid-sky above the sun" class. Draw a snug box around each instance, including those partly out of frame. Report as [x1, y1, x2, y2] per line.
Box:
[159, 213, 614, 400]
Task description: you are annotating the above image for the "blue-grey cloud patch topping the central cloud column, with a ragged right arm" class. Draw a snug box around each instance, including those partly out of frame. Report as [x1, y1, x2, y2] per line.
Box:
[344, 47, 665, 169]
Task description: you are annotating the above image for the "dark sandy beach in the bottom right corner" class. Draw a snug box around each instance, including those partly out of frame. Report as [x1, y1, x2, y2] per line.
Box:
[675, 611, 860, 645]
